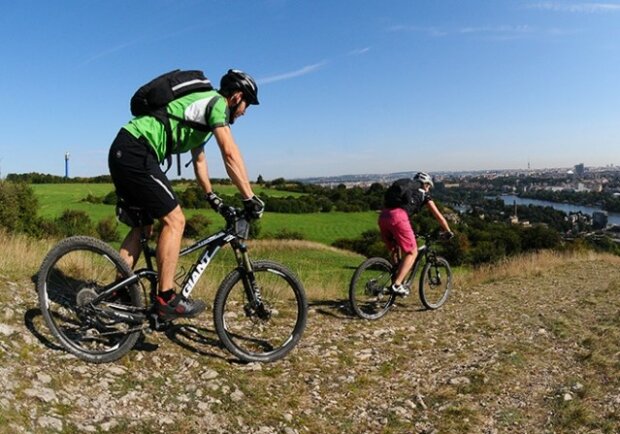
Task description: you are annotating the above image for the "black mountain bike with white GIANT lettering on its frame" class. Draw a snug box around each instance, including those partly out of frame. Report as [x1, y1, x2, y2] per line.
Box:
[37, 207, 308, 363]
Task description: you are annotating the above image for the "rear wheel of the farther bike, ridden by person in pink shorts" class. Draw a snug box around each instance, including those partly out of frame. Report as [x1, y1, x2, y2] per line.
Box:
[349, 257, 396, 320]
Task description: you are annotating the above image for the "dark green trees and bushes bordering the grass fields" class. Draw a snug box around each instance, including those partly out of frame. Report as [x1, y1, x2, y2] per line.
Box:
[0, 177, 620, 265]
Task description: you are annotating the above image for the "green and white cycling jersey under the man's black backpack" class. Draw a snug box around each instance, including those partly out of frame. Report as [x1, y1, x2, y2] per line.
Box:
[123, 90, 229, 163]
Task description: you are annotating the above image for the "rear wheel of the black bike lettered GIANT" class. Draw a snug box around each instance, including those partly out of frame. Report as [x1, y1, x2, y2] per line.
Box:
[37, 236, 143, 363]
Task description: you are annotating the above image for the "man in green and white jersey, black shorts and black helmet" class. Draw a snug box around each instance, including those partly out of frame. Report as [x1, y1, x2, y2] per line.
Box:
[108, 69, 265, 320]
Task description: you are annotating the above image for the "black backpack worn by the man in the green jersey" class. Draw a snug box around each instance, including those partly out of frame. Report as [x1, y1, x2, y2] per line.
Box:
[129, 69, 215, 170]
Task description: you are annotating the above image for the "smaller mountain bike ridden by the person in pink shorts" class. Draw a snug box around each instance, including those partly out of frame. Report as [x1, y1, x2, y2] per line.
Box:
[349, 233, 452, 319]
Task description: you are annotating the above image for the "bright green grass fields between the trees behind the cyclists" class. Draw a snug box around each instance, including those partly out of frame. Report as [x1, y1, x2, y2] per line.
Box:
[32, 184, 377, 245]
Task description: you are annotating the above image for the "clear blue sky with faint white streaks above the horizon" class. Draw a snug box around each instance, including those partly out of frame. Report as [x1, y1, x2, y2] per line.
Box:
[0, 0, 620, 179]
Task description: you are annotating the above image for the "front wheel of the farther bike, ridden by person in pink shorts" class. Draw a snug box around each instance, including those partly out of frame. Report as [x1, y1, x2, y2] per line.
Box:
[420, 256, 452, 309]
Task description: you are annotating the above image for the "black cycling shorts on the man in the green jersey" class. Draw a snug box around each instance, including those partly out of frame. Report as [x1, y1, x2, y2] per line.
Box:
[108, 128, 179, 224]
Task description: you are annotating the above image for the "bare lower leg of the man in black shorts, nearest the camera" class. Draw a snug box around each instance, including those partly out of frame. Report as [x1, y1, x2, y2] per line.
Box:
[157, 205, 185, 292]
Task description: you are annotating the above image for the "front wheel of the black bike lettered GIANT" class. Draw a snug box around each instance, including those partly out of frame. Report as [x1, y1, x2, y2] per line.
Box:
[213, 261, 308, 362]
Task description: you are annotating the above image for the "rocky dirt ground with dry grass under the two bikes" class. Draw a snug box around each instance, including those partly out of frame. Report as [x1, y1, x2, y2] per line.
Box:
[0, 257, 620, 434]
